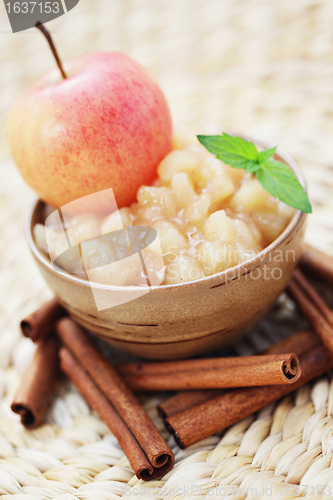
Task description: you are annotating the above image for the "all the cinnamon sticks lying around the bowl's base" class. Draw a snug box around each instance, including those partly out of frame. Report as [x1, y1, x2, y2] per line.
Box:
[12, 247, 333, 480]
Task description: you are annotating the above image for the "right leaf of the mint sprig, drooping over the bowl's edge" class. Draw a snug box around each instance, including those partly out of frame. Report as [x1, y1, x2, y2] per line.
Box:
[256, 160, 312, 213]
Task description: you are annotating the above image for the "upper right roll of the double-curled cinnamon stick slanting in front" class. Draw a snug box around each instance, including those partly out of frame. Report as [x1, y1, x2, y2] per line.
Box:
[56, 318, 174, 476]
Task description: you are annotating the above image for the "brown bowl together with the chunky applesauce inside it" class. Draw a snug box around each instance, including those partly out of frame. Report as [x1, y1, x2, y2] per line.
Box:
[28, 134, 305, 359]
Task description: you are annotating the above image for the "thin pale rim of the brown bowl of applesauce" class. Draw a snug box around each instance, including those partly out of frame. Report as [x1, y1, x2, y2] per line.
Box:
[25, 140, 306, 292]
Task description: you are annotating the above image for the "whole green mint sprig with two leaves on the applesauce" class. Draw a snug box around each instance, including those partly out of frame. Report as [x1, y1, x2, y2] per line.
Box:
[197, 133, 312, 213]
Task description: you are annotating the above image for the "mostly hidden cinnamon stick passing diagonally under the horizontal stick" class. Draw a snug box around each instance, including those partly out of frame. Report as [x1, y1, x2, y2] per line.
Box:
[157, 330, 321, 418]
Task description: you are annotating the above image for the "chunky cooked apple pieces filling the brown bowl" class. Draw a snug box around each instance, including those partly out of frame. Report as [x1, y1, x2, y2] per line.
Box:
[34, 131, 295, 286]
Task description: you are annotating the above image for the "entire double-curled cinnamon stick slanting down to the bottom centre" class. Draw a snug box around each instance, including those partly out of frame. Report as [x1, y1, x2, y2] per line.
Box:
[56, 318, 174, 480]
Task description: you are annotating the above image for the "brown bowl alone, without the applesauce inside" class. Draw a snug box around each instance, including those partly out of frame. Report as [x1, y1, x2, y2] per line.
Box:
[27, 146, 306, 359]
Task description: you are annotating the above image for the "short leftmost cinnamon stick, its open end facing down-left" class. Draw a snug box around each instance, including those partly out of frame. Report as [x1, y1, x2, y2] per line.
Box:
[11, 337, 59, 429]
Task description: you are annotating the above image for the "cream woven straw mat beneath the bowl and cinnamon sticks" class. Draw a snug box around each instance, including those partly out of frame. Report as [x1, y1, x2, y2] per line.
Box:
[0, 0, 333, 500]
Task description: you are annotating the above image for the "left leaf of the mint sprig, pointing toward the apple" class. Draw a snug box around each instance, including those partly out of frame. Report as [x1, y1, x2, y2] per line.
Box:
[197, 133, 258, 169]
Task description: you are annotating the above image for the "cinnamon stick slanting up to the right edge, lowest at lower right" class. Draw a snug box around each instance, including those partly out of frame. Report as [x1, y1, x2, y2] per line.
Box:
[165, 346, 333, 448]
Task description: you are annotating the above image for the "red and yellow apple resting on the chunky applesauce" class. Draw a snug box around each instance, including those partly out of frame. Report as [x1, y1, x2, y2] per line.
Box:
[7, 52, 172, 213]
